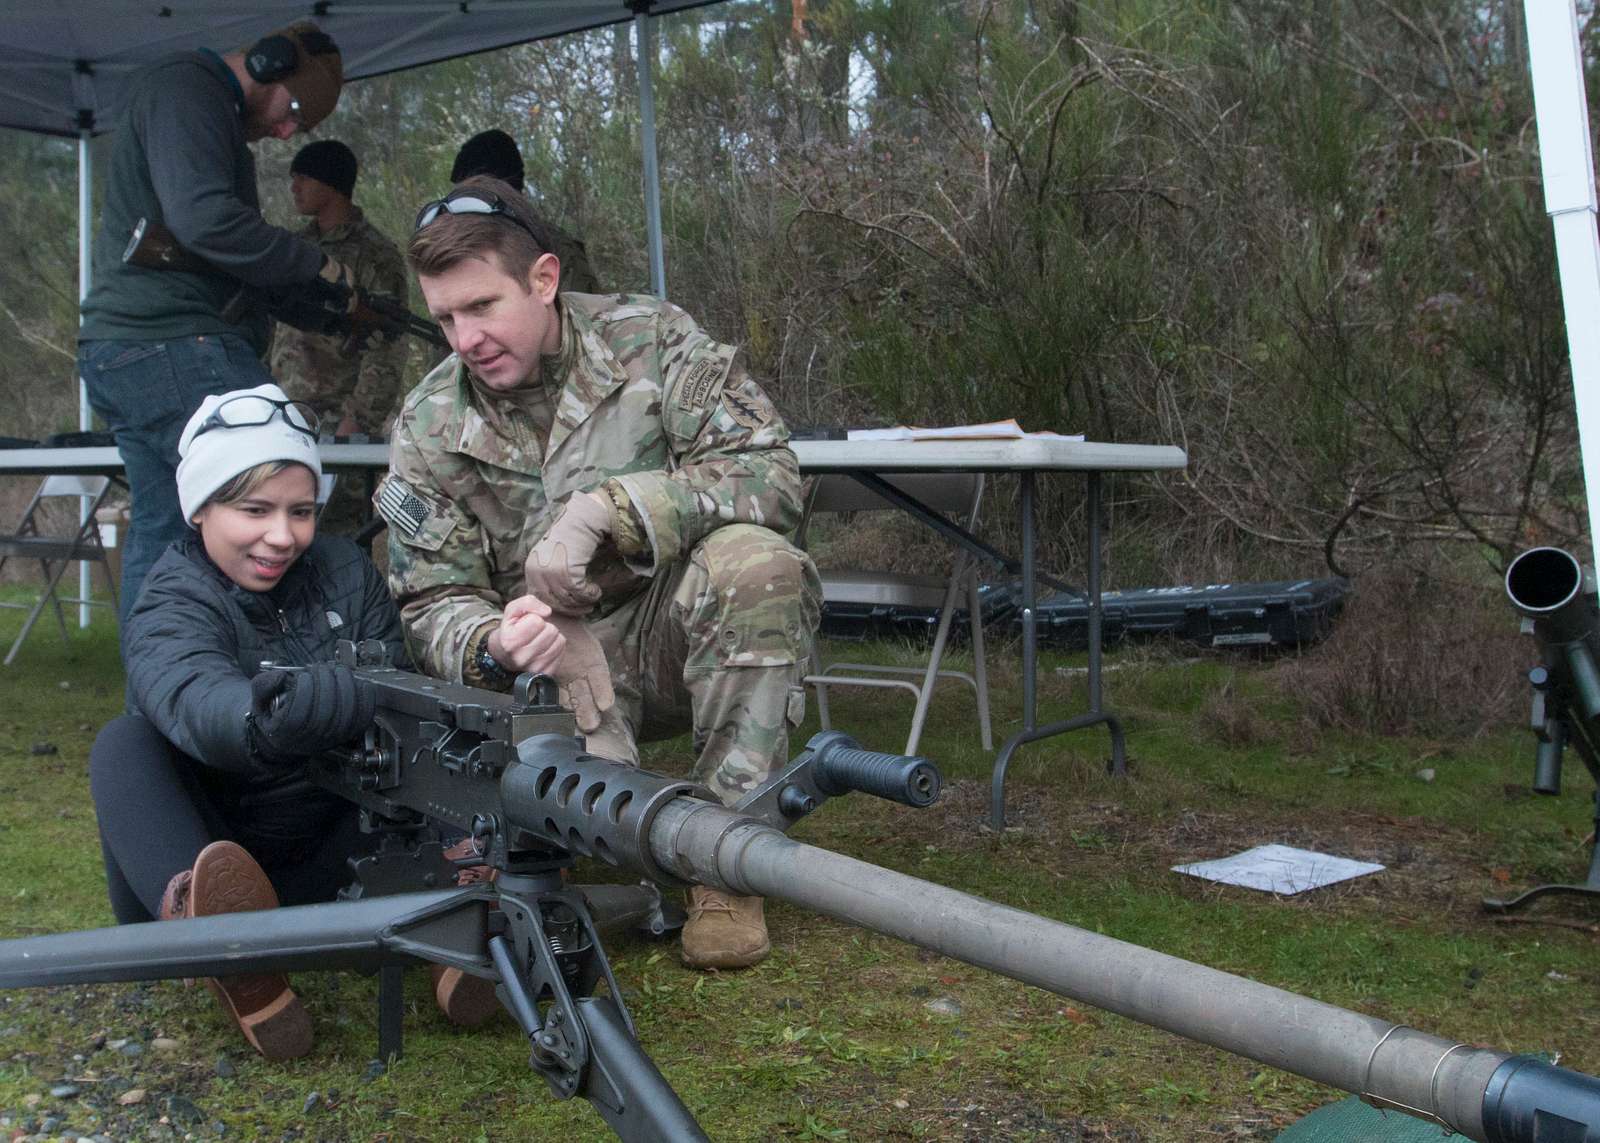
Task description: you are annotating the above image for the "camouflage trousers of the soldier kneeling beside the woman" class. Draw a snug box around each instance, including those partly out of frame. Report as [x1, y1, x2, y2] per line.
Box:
[586, 523, 822, 804]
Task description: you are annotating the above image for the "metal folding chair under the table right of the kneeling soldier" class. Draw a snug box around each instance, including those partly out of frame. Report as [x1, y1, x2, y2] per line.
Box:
[795, 472, 994, 754]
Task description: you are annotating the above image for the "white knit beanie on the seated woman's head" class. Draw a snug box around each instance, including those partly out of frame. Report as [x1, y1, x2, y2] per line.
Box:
[178, 384, 322, 528]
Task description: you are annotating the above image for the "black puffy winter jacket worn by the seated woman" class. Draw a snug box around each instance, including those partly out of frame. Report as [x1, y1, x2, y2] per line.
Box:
[122, 535, 406, 788]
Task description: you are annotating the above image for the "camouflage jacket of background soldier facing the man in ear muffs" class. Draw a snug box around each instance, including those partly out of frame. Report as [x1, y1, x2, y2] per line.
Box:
[270, 207, 410, 432]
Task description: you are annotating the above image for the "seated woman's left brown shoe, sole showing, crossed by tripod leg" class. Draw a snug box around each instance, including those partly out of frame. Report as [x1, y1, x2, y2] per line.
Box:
[160, 842, 312, 1060]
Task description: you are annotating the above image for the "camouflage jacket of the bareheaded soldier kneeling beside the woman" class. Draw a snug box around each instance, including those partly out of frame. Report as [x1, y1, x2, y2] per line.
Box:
[374, 293, 802, 680]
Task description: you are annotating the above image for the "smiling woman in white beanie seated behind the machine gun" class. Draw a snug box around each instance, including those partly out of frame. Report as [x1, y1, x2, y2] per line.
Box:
[90, 384, 405, 1060]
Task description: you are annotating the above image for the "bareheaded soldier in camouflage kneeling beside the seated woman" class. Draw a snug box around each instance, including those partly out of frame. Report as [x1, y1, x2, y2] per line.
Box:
[376, 179, 821, 967]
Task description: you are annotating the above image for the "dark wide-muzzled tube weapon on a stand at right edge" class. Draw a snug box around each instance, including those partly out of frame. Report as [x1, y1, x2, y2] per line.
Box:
[1483, 547, 1600, 912]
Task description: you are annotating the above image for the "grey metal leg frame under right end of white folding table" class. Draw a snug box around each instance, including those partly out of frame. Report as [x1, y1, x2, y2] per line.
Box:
[989, 472, 1128, 831]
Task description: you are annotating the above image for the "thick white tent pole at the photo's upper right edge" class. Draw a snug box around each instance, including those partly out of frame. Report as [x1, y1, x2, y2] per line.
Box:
[1523, 0, 1600, 567]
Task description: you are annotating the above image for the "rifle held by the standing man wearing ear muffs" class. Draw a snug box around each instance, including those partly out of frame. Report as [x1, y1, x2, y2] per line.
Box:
[122, 218, 450, 351]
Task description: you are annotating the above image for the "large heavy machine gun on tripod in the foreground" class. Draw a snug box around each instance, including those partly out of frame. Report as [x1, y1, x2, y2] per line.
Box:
[0, 645, 1600, 1143]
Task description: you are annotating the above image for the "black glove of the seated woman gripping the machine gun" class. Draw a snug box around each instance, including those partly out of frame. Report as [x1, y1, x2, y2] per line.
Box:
[250, 663, 378, 762]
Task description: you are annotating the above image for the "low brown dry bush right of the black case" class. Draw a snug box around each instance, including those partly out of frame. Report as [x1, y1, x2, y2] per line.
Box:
[1274, 563, 1536, 735]
